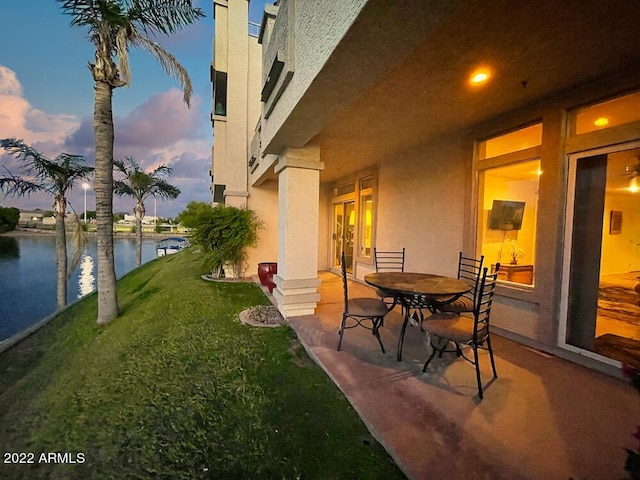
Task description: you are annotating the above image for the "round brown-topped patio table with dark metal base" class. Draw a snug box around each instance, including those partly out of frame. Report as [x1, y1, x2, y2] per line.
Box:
[364, 272, 473, 361]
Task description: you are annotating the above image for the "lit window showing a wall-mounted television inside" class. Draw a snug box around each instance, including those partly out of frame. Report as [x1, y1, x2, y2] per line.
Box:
[477, 124, 542, 285]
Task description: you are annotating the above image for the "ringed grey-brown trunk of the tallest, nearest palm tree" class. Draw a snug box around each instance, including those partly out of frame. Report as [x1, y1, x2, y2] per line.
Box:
[93, 80, 119, 324]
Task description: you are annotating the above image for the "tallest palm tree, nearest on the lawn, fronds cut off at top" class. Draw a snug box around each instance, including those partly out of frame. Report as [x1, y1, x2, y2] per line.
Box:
[57, 0, 204, 324]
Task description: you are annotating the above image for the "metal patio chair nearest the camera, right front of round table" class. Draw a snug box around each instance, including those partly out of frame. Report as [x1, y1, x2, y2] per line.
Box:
[421, 264, 499, 399]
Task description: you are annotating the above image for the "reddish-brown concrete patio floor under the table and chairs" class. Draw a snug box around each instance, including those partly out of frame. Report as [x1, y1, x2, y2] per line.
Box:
[278, 272, 640, 480]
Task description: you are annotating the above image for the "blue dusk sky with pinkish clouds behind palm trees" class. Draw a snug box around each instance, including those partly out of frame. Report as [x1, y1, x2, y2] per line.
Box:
[0, 0, 273, 217]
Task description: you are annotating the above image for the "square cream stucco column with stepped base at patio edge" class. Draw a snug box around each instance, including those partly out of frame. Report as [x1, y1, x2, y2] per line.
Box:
[273, 147, 324, 317]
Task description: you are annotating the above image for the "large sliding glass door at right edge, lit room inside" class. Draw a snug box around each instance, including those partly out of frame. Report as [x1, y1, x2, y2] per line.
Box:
[560, 144, 640, 363]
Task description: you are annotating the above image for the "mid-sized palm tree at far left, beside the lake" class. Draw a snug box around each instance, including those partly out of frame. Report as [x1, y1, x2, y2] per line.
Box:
[0, 138, 93, 309]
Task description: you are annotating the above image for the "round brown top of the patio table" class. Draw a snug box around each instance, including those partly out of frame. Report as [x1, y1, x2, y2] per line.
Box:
[364, 272, 473, 297]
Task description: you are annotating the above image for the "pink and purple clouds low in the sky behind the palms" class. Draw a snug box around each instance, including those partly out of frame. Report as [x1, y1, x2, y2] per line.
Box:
[0, 65, 211, 217]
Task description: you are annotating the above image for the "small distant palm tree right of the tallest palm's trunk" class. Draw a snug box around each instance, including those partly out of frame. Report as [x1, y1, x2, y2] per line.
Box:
[113, 157, 180, 267]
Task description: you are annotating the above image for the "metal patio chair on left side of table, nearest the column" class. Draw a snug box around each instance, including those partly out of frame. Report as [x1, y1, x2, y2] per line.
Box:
[338, 252, 389, 353]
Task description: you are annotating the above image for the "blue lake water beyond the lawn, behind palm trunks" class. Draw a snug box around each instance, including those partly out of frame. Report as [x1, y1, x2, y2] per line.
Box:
[0, 235, 156, 341]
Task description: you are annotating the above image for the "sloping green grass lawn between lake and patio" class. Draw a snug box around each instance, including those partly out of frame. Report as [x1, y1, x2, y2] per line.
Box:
[0, 250, 404, 479]
